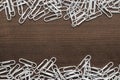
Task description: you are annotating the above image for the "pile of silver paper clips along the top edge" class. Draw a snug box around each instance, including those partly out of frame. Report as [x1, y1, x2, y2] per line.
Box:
[0, 0, 120, 27]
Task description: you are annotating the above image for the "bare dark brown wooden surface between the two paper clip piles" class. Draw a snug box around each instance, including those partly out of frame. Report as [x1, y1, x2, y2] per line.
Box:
[0, 12, 120, 67]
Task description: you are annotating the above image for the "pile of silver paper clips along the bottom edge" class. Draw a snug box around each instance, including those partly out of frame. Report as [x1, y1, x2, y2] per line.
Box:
[0, 55, 120, 80]
